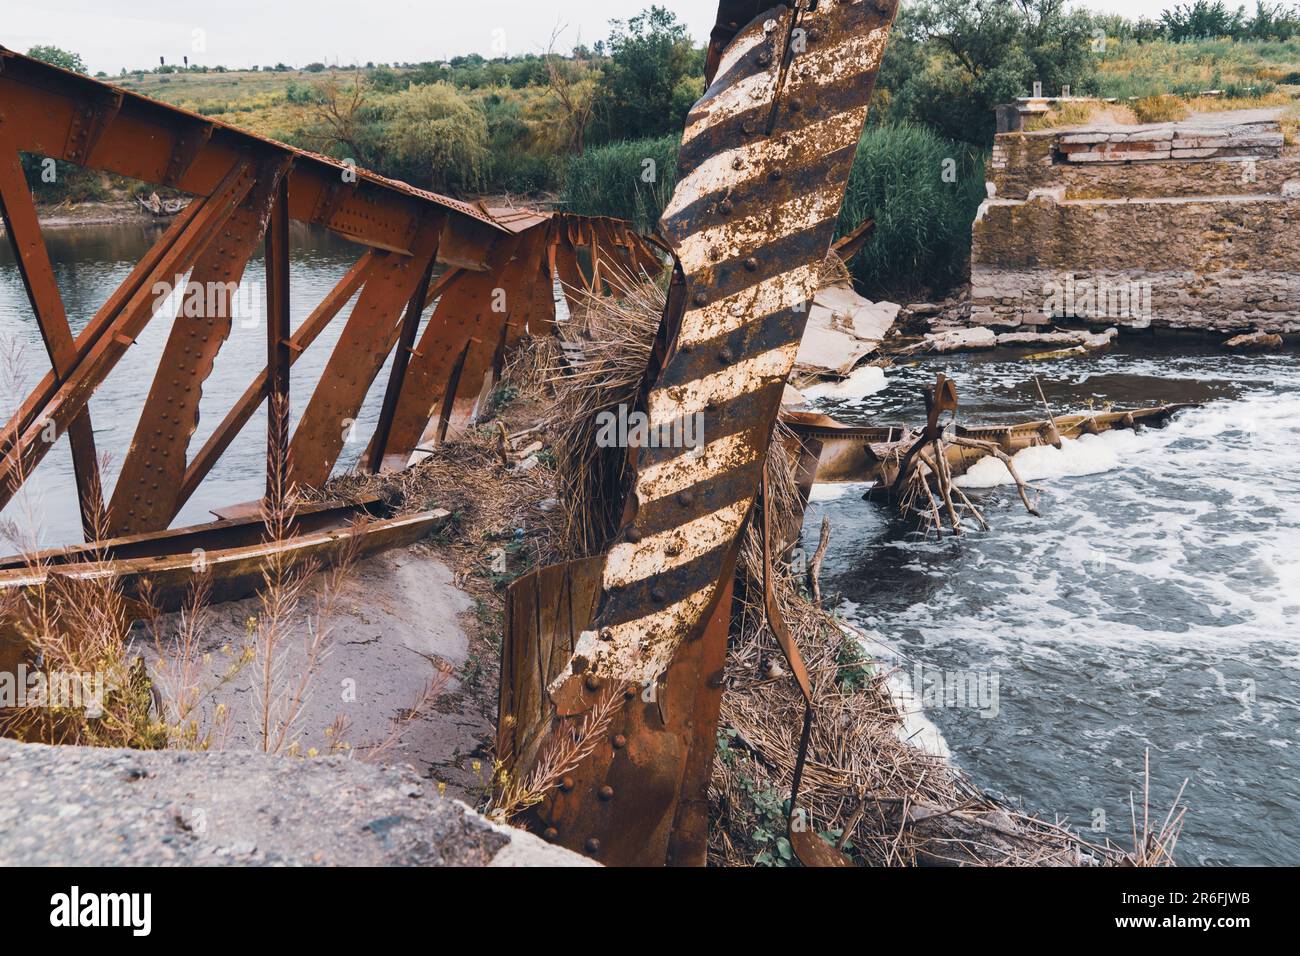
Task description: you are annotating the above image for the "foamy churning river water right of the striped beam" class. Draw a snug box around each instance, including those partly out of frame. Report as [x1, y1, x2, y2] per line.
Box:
[805, 350, 1300, 864]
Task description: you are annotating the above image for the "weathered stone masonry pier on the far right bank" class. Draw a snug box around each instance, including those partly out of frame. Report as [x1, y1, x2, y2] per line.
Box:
[970, 111, 1300, 334]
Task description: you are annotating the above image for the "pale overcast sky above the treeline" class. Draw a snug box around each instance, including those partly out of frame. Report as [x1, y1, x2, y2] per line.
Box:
[0, 0, 1190, 74]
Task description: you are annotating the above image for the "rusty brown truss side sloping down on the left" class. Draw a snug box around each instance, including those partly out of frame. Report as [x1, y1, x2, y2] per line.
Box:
[0, 47, 660, 535]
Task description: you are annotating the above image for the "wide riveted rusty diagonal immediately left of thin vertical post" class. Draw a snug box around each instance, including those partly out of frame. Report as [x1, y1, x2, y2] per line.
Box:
[108, 164, 286, 535]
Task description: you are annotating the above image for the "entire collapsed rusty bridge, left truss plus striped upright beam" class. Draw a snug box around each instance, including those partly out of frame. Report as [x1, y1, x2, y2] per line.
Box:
[0, 0, 897, 865]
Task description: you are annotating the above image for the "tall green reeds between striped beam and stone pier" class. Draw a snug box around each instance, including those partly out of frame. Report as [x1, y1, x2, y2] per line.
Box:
[839, 125, 984, 295]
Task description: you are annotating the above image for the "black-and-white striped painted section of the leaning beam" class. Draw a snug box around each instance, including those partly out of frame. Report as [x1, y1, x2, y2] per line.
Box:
[553, 3, 893, 698]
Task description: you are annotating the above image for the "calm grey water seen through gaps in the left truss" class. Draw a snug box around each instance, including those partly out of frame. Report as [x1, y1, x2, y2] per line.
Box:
[0, 224, 397, 551]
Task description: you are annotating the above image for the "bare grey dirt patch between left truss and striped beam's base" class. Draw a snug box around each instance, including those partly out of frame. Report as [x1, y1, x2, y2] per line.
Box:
[147, 542, 495, 804]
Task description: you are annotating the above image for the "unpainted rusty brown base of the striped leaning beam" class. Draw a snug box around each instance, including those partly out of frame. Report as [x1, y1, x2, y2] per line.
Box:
[498, 558, 731, 866]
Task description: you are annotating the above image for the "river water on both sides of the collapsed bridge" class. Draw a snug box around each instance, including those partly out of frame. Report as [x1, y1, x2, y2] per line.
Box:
[0, 226, 1300, 865]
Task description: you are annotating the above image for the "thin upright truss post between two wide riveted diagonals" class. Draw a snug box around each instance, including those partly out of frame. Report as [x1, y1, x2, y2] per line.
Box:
[267, 176, 293, 498]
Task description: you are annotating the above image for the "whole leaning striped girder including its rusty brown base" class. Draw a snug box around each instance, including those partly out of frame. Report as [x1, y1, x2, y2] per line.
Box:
[499, 0, 897, 865]
